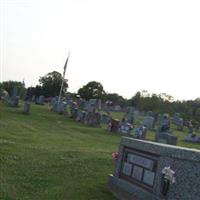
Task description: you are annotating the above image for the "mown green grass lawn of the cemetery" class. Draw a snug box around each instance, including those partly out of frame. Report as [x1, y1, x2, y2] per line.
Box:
[0, 102, 200, 200]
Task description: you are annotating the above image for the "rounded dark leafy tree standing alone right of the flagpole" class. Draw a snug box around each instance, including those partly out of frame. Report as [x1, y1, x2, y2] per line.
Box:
[78, 81, 106, 100]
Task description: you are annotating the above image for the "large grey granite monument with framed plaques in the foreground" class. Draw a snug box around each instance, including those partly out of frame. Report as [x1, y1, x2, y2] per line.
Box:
[108, 137, 200, 200]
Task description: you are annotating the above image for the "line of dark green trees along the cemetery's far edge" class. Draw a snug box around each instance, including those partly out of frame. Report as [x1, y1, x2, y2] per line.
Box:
[0, 71, 200, 122]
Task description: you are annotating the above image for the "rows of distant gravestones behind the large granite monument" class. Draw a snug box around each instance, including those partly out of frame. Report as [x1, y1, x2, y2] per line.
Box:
[12, 92, 200, 144]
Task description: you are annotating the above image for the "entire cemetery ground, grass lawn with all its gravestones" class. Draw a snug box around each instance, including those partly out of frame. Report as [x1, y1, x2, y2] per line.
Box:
[0, 97, 200, 200]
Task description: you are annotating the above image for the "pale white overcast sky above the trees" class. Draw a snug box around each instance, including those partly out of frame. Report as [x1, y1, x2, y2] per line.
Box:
[0, 0, 200, 100]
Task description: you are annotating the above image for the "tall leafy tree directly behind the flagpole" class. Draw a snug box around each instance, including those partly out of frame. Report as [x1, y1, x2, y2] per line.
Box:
[39, 71, 68, 97]
